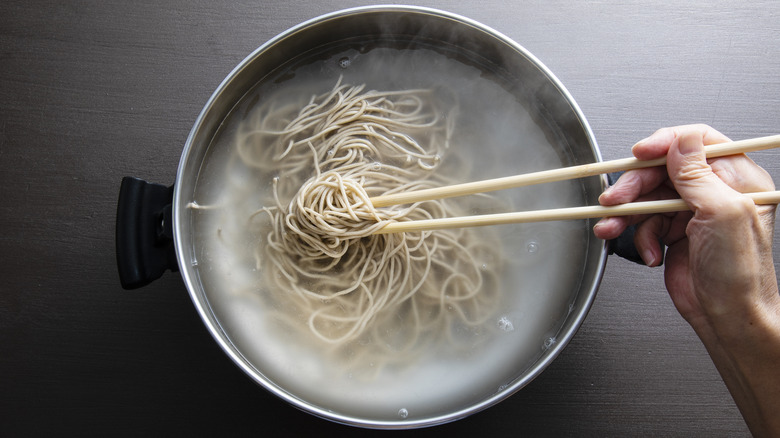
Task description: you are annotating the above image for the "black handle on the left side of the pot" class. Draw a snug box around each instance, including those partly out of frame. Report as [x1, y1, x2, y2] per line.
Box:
[116, 177, 179, 289]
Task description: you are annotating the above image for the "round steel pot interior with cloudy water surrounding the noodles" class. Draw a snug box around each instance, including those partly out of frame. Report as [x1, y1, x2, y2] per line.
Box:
[175, 8, 605, 428]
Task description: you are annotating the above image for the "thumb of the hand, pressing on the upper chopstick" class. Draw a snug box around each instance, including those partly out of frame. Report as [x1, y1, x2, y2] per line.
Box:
[666, 132, 738, 213]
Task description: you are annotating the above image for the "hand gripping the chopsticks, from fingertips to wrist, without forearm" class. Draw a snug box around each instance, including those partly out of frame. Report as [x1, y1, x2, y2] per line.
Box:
[594, 125, 778, 325]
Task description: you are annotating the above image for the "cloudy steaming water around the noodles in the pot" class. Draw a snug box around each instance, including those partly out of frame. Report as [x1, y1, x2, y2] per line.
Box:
[192, 44, 590, 422]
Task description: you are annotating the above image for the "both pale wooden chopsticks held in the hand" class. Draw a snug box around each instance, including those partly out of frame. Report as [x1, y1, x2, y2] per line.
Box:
[371, 135, 780, 234]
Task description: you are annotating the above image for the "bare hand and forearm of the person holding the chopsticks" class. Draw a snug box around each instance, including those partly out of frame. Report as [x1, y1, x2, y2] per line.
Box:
[594, 125, 780, 436]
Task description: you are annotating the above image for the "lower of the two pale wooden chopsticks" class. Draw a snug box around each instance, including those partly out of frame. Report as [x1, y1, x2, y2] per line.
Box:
[375, 191, 780, 234]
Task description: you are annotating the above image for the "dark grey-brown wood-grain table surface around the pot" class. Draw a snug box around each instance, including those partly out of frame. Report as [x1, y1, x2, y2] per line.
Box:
[0, 0, 780, 436]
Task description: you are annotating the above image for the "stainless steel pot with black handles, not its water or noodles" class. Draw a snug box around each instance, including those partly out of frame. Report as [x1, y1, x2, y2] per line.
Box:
[117, 6, 640, 428]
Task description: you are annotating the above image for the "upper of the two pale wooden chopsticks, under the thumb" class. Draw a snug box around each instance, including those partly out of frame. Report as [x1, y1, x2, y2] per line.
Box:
[371, 135, 780, 207]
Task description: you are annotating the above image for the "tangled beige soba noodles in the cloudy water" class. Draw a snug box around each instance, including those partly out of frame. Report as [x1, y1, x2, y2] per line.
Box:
[238, 80, 499, 372]
